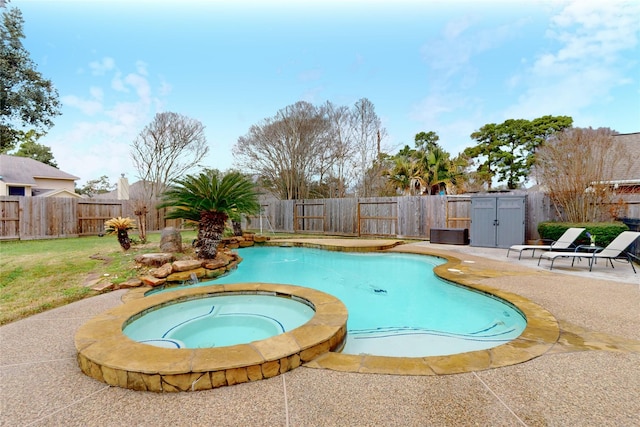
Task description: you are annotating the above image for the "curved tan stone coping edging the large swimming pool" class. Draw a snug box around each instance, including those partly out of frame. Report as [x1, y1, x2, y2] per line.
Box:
[262, 239, 560, 375]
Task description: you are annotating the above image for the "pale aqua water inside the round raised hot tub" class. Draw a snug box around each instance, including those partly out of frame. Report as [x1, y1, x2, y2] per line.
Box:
[123, 294, 315, 348]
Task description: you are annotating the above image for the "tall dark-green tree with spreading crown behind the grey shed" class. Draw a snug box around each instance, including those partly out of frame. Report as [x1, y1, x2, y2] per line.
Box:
[464, 116, 573, 190]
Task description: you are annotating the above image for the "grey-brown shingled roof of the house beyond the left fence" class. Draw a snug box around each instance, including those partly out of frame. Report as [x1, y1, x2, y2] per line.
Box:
[0, 154, 80, 186]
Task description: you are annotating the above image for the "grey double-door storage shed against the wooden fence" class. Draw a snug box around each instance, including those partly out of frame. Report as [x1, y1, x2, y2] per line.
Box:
[470, 196, 526, 248]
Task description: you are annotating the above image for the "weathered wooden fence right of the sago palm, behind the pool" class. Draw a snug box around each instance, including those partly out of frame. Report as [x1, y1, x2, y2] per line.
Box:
[246, 193, 553, 239]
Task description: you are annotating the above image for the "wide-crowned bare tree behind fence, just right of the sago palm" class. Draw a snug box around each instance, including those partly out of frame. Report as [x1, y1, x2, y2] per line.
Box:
[233, 101, 329, 200]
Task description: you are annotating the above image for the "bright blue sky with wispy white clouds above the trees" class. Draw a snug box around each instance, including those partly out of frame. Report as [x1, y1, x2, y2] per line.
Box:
[8, 0, 640, 186]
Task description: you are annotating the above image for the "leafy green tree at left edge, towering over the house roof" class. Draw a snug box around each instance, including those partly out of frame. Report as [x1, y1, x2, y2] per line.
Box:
[0, 2, 60, 153]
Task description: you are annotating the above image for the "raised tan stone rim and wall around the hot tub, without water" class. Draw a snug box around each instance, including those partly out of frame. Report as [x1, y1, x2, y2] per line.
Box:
[75, 283, 347, 392]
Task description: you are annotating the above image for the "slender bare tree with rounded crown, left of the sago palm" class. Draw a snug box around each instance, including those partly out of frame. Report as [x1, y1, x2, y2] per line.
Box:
[131, 112, 209, 241]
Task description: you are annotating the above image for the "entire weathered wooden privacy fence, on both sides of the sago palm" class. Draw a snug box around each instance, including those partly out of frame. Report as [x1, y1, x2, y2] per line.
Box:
[0, 192, 640, 240]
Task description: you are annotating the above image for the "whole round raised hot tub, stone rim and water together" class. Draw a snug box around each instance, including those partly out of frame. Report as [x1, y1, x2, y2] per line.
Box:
[75, 283, 347, 392]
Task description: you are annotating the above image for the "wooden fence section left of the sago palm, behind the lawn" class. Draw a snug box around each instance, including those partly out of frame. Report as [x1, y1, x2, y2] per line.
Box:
[0, 196, 181, 240]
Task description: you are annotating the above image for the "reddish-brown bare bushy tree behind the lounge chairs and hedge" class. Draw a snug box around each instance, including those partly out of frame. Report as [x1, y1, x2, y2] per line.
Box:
[536, 128, 623, 222]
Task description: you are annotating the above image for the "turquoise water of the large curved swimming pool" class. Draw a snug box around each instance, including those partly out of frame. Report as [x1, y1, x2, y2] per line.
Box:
[152, 247, 526, 357]
